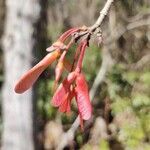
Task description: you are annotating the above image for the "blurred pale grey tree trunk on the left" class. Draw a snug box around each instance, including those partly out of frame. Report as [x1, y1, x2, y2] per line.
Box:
[2, 0, 40, 150]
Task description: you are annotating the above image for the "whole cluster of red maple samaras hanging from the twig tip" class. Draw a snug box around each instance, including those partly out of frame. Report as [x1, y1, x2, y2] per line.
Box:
[15, 26, 101, 126]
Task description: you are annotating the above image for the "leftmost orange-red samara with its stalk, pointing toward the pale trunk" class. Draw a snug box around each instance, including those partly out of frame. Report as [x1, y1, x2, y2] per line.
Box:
[15, 28, 79, 93]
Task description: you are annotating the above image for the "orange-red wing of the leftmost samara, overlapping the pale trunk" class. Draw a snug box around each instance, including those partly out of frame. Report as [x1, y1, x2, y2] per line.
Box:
[14, 52, 58, 94]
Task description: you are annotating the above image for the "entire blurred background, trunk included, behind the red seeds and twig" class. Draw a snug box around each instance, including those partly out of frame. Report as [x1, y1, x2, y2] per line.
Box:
[0, 0, 150, 150]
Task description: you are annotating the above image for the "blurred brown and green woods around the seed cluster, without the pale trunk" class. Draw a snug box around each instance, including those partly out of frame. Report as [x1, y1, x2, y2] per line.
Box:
[0, 0, 150, 150]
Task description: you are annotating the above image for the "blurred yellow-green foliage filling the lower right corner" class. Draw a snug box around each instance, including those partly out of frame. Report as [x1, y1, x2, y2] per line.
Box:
[108, 65, 150, 150]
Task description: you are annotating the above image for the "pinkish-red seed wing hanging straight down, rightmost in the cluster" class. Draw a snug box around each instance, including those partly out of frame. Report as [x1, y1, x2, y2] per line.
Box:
[75, 74, 92, 120]
